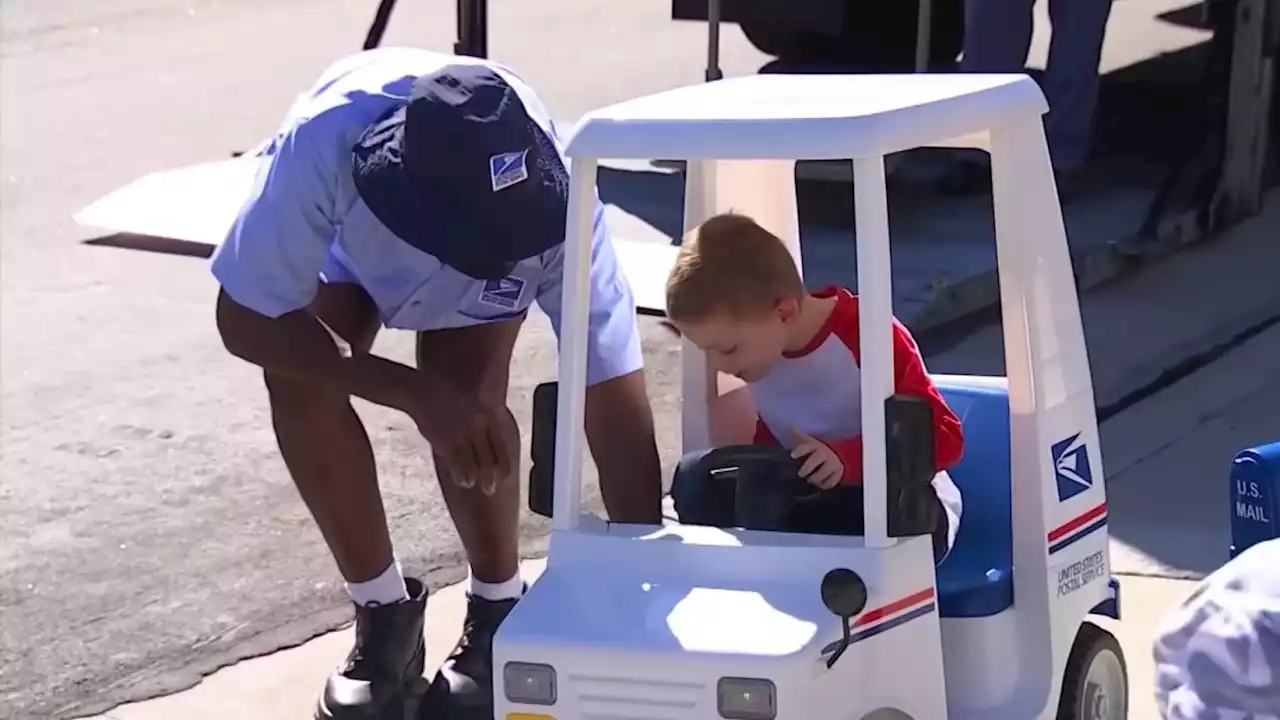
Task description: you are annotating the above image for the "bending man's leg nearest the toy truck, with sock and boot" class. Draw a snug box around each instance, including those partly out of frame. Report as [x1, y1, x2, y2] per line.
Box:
[417, 316, 524, 720]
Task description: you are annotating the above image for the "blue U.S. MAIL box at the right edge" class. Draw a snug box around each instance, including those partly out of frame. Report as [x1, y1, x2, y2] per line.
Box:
[1231, 442, 1280, 557]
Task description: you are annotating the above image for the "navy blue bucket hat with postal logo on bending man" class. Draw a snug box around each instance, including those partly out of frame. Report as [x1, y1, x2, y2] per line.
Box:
[352, 64, 568, 279]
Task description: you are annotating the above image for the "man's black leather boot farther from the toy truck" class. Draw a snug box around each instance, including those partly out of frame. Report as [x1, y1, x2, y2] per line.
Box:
[316, 578, 426, 720]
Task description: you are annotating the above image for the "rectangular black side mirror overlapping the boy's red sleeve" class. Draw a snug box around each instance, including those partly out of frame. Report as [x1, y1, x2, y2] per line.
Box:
[884, 395, 940, 538]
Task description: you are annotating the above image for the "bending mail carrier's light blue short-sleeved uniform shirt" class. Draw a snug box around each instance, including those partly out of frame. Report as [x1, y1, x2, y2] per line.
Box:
[212, 47, 643, 384]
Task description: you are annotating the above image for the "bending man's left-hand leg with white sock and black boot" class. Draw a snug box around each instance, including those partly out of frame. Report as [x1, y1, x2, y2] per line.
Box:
[266, 283, 426, 720]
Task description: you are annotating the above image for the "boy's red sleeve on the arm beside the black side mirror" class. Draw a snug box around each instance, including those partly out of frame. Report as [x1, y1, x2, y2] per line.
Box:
[824, 295, 964, 484]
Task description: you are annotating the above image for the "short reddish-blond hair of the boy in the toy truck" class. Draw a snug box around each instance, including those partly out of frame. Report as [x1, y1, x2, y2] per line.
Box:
[667, 213, 805, 323]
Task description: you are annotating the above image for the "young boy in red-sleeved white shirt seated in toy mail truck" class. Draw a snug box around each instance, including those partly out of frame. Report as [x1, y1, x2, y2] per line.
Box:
[667, 213, 964, 561]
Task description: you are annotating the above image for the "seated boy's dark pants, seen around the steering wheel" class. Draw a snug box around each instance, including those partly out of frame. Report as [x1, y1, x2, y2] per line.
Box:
[671, 450, 950, 562]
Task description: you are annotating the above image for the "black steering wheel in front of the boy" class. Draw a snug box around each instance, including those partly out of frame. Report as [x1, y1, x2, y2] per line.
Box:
[698, 445, 823, 530]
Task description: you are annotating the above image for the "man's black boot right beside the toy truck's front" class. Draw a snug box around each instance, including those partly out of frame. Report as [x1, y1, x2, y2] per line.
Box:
[420, 594, 517, 720]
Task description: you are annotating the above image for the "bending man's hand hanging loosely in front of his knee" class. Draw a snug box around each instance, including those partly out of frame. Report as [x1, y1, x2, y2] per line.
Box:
[404, 378, 520, 495]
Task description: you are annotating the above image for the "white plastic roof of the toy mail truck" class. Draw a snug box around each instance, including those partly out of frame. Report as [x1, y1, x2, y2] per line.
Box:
[567, 73, 1048, 160]
